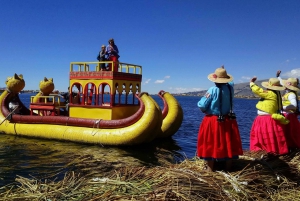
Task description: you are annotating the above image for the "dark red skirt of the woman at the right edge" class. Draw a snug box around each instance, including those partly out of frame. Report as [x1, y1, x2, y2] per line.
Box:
[284, 113, 300, 148]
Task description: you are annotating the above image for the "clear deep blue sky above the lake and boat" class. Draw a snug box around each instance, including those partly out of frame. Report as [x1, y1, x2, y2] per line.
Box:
[0, 0, 300, 94]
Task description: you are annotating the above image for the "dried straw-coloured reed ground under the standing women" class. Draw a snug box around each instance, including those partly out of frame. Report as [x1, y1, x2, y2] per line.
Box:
[0, 151, 300, 201]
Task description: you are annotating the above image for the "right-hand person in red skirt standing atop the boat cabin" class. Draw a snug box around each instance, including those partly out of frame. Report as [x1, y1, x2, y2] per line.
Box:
[106, 38, 120, 72]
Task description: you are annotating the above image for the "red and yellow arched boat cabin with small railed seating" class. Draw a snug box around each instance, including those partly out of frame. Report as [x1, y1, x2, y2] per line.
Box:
[30, 61, 142, 120]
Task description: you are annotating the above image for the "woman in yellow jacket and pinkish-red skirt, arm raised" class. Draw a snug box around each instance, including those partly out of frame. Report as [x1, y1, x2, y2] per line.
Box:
[250, 77, 289, 155]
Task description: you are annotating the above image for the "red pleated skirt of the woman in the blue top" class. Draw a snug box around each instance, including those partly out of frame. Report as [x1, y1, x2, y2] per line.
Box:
[197, 115, 243, 161]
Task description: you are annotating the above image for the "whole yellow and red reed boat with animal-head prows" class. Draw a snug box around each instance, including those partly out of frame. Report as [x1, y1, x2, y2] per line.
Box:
[0, 61, 183, 145]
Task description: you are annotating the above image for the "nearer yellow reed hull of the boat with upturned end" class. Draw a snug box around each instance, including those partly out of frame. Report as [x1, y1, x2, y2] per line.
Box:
[0, 92, 162, 145]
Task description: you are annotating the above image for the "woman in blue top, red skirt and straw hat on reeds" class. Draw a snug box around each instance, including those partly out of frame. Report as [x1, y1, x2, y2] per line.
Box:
[197, 66, 243, 171]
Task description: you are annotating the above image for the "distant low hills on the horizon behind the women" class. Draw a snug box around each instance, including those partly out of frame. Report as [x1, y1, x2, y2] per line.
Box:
[175, 80, 274, 98]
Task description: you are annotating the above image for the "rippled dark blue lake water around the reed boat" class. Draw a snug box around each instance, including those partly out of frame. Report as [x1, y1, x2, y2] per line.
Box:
[0, 94, 257, 186]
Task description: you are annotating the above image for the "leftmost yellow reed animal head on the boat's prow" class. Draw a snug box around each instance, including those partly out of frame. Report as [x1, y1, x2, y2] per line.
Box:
[5, 73, 25, 94]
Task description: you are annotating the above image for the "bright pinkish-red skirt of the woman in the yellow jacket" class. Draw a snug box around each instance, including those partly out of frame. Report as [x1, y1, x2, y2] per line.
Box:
[250, 115, 288, 155]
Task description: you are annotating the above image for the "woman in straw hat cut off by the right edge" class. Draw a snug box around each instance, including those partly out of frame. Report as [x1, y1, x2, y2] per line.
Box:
[276, 70, 300, 151]
